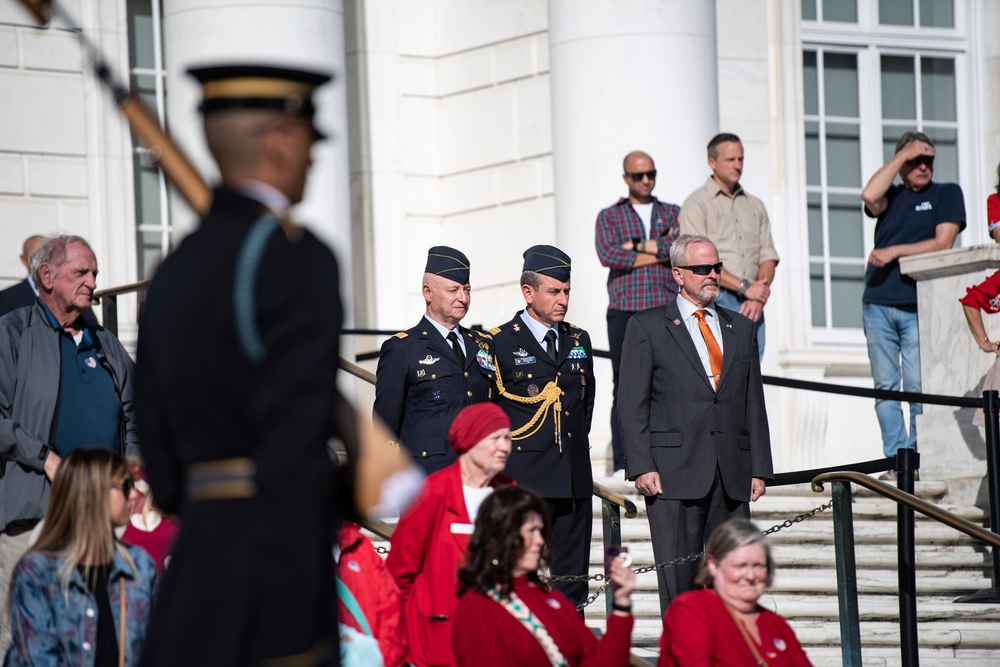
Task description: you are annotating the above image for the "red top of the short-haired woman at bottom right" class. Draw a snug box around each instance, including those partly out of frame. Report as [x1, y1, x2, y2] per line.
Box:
[656, 588, 812, 667]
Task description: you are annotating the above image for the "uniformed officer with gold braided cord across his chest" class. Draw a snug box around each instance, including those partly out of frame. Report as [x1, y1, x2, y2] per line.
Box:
[490, 245, 594, 604]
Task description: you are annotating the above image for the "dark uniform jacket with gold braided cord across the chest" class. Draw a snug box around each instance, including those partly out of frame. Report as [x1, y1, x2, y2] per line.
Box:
[490, 313, 594, 498]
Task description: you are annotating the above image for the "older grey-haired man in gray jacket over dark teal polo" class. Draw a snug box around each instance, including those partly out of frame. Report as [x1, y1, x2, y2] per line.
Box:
[0, 236, 139, 652]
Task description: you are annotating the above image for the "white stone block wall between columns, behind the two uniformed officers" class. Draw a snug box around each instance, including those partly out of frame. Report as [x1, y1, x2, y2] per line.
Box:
[349, 0, 555, 334]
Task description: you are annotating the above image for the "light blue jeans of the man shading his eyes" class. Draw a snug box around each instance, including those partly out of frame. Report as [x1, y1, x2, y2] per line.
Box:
[862, 303, 924, 457]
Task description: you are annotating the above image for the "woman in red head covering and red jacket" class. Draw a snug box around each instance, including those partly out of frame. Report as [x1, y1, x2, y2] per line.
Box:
[386, 403, 513, 667]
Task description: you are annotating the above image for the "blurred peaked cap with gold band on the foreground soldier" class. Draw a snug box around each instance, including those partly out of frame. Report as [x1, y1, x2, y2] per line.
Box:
[188, 63, 332, 138]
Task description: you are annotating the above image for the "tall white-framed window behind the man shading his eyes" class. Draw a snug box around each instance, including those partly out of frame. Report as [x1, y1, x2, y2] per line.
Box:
[802, 0, 965, 334]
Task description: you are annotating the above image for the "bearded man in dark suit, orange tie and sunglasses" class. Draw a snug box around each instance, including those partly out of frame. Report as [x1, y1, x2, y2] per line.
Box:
[618, 235, 772, 611]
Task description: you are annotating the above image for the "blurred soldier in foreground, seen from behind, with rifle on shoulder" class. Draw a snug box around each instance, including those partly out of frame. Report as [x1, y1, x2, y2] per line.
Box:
[137, 66, 342, 667]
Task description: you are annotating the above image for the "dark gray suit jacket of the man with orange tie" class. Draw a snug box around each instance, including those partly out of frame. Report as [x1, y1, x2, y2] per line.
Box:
[618, 297, 774, 501]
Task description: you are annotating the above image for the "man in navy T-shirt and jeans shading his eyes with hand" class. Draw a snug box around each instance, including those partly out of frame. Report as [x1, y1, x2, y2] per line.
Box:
[861, 132, 965, 479]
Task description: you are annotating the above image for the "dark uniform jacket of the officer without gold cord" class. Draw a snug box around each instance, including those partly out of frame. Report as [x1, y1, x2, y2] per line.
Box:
[374, 317, 495, 474]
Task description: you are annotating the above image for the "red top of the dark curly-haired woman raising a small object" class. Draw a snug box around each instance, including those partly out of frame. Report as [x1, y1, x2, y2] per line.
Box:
[452, 577, 633, 667]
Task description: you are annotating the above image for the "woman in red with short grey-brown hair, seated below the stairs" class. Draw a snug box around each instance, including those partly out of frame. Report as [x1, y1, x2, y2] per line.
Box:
[657, 519, 812, 667]
